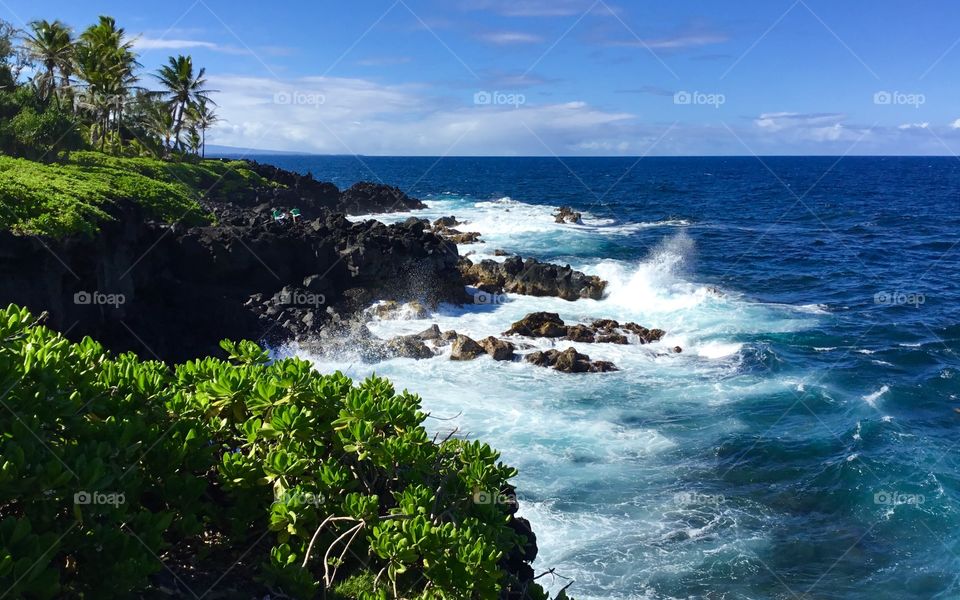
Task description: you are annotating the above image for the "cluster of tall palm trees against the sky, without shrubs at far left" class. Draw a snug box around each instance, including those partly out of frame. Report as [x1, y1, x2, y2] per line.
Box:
[24, 16, 217, 156]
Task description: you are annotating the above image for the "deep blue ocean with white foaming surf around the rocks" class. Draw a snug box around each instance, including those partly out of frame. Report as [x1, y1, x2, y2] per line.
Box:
[246, 156, 960, 600]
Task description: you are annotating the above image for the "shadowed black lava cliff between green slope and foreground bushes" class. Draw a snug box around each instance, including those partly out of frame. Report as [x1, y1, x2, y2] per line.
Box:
[0, 203, 463, 361]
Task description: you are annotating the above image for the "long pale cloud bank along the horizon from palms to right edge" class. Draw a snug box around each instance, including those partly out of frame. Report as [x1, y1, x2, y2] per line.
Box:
[209, 76, 960, 156]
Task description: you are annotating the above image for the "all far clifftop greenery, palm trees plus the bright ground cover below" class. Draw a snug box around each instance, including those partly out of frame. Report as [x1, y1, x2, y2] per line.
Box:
[0, 16, 280, 237]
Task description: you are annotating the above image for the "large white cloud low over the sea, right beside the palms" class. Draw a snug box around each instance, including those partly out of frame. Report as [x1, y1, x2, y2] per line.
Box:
[210, 76, 634, 156]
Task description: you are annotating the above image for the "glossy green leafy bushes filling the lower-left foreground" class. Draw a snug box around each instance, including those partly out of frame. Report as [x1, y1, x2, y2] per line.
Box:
[0, 306, 545, 599]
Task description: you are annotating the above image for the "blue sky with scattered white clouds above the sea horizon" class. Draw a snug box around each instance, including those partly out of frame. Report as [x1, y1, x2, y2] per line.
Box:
[0, 0, 960, 156]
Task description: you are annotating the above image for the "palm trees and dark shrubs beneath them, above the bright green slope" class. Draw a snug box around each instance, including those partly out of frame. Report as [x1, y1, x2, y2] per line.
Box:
[0, 16, 217, 161]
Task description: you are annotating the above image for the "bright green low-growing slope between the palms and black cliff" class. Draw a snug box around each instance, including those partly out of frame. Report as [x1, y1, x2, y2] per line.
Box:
[0, 152, 270, 237]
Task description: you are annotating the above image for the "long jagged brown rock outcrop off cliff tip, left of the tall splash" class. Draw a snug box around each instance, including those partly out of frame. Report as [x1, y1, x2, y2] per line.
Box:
[459, 256, 607, 300]
